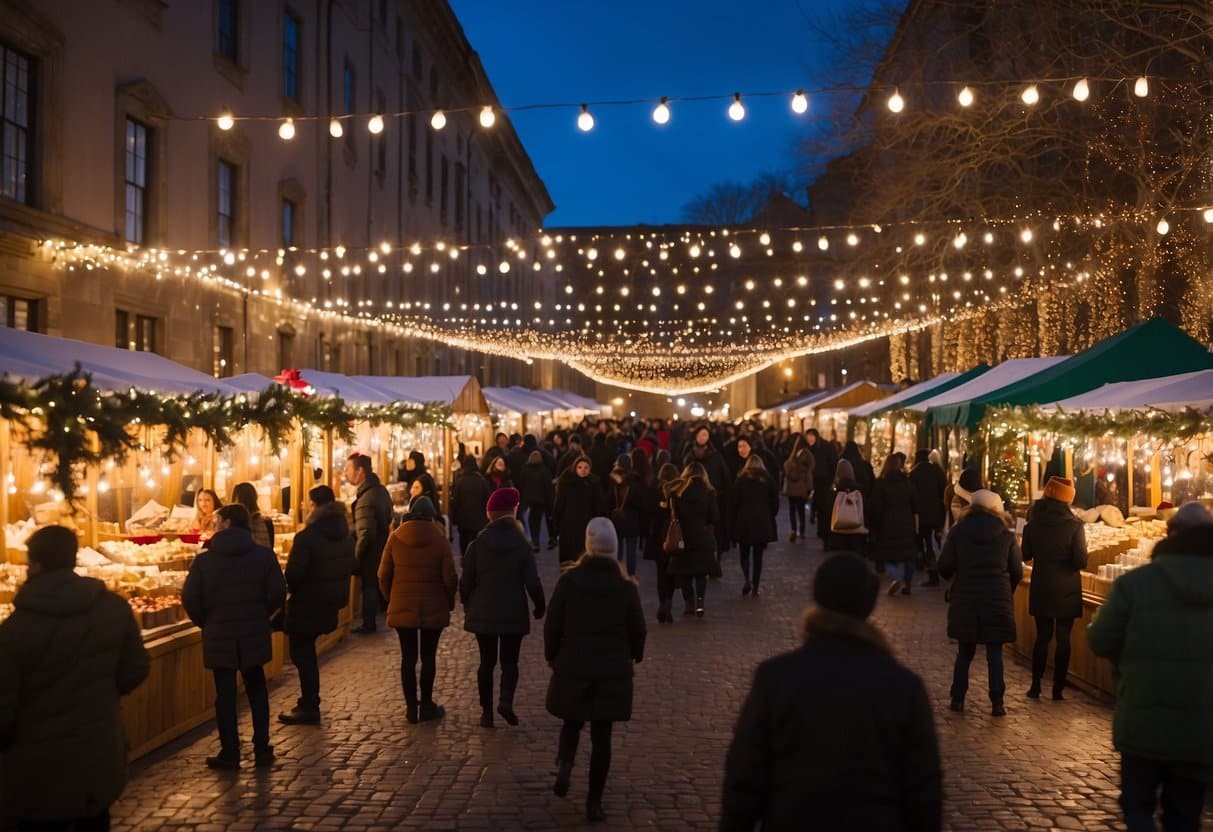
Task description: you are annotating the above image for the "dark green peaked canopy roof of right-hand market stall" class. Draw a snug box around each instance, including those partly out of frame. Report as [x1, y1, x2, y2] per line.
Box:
[927, 318, 1213, 431]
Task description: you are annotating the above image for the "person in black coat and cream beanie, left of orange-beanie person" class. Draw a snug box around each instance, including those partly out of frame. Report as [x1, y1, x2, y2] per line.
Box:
[939, 489, 1024, 717]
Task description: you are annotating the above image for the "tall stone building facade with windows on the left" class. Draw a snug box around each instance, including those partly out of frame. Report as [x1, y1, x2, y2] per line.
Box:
[0, 0, 592, 389]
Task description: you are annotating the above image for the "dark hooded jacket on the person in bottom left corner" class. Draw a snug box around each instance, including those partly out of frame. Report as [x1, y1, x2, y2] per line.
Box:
[0, 569, 150, 821]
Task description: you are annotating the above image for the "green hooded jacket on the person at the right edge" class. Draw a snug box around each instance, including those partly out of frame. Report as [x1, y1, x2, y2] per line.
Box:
[1087, 525, 1213, 782]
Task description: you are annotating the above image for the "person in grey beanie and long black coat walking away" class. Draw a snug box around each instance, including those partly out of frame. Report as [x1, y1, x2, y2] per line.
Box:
[543, 518, 645, 822]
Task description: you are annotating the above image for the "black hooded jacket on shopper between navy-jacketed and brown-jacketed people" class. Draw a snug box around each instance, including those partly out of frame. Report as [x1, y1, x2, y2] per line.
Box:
[286, 502, 358, 636]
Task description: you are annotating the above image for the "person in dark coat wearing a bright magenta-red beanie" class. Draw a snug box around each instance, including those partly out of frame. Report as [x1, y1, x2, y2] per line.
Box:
[459, 489, 545, 728]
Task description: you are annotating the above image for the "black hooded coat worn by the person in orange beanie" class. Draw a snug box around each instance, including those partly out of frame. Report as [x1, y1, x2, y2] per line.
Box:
[1021, 497, 1087, 619]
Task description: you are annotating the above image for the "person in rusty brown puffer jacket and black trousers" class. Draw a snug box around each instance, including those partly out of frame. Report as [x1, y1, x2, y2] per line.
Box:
[378, 497, 459, 724]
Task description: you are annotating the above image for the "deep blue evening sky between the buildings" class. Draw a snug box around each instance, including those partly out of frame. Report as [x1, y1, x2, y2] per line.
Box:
[450, 0, 848, 227]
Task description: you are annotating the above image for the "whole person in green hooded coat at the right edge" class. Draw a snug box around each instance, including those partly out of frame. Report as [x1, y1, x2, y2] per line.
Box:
[1087, 503, 1213, 832]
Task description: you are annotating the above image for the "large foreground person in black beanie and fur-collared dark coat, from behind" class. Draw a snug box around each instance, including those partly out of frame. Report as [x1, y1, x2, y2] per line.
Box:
[719, 554, 943, 832]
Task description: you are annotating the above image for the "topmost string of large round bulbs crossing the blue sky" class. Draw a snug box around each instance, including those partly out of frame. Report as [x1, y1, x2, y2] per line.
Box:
[194, 74, 1208, 142]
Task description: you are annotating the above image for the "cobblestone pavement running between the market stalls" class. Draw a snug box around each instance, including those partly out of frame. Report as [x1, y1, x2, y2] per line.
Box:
[114, 523, 1213, 832]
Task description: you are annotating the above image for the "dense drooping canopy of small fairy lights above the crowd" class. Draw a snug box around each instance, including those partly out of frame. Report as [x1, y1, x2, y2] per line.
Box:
[40, 200, 1213, 393]
